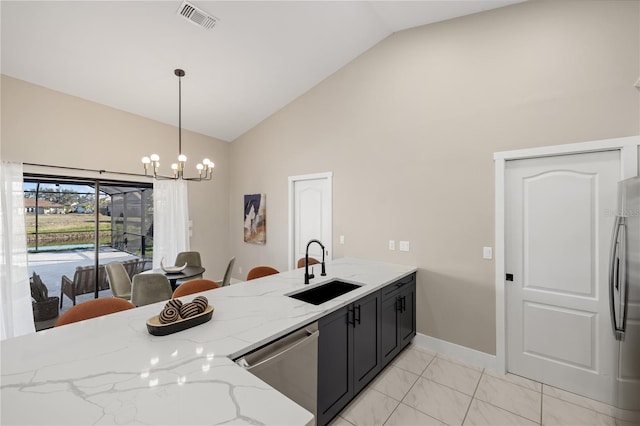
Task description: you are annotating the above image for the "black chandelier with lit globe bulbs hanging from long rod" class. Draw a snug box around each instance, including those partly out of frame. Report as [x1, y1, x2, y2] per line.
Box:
[142, 69, 214, 182]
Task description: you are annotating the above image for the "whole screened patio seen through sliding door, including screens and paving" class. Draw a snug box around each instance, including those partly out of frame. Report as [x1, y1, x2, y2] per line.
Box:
[24, 175, 153, 329]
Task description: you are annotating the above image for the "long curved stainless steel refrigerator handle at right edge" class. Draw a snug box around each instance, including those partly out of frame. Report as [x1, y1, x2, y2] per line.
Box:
[609, 216, 626, 340]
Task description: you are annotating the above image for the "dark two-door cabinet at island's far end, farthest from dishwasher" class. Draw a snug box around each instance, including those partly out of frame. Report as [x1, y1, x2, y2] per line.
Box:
[380, 273, 416, 368]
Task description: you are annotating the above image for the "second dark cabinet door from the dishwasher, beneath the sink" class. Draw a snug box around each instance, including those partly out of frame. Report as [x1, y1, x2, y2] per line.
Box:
[352, 292, 382, 395]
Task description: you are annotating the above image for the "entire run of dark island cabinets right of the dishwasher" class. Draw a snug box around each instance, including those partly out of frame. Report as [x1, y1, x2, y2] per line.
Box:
[316, 273, 416, 426]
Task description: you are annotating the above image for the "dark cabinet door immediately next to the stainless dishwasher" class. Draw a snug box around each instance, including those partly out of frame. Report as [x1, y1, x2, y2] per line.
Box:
[316, 306, 353, 425]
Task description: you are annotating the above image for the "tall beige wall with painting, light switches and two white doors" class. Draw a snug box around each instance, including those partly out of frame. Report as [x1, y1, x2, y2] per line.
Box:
[229, 1, 640, 354]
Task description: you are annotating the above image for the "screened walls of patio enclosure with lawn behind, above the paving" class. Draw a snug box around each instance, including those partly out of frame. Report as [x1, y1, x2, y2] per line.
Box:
[24, 176, 153, 258]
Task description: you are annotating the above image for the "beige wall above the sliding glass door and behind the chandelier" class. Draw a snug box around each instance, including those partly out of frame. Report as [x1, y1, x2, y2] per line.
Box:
[1, 75, 229, 279]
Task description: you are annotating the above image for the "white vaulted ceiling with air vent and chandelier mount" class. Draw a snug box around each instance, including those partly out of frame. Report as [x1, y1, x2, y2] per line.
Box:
[0, 0, 523, 141]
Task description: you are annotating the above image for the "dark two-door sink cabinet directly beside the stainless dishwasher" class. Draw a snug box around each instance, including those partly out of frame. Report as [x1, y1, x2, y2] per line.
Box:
[317, 292, 382, 425]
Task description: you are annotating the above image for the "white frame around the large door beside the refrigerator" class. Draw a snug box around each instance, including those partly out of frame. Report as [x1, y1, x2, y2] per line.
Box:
[493, 136, 640, 373]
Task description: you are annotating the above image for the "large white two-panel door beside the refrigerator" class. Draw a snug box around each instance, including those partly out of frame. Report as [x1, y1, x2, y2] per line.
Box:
[505, 150, 620, 403]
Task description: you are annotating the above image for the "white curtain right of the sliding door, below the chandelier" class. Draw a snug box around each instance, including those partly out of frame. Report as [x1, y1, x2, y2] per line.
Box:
[153, 180, 189, 268]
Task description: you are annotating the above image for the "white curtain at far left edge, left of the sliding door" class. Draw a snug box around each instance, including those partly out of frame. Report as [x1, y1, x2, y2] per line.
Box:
[0, 161, 35, 340]
